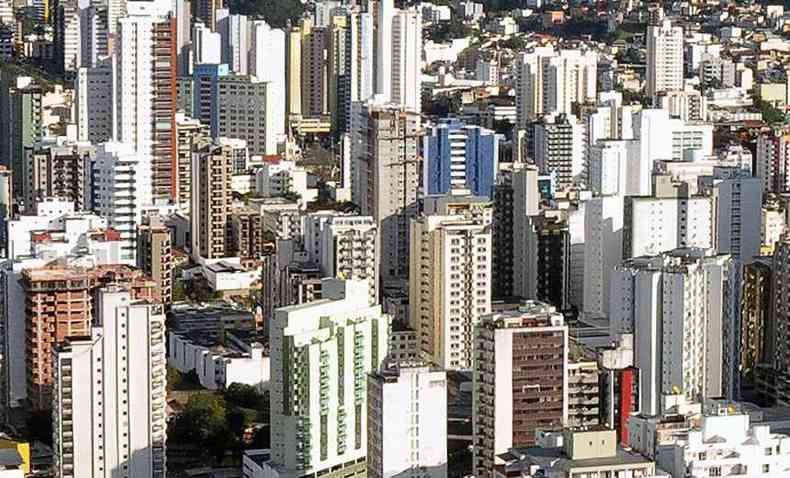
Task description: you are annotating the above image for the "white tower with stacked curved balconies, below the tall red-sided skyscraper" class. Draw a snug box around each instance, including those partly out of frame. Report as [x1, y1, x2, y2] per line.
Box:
[93, 142, 153, 265]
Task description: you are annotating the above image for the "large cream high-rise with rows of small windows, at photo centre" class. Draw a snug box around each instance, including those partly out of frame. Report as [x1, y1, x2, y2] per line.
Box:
[409, 191, 493, 370]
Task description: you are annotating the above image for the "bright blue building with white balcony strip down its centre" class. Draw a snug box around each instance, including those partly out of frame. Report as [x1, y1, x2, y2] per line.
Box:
[423, 118, 500, 197]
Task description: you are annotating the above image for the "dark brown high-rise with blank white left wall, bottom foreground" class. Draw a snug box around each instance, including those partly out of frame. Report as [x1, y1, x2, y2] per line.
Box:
[472, 301, 568, 477]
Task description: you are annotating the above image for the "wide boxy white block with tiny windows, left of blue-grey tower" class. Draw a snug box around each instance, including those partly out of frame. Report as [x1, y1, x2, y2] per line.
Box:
[623, 196, 715, 257]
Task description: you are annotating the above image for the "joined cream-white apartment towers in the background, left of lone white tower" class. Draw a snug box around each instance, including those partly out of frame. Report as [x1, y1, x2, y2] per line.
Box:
[516, 47, 598, 128]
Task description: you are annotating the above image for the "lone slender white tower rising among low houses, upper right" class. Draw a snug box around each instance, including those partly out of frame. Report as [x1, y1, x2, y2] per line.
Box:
[645, 20, 683, 101]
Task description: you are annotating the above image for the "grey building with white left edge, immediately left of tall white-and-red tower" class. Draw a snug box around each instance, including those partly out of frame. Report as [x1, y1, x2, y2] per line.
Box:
[74, 59, 113, 144]
